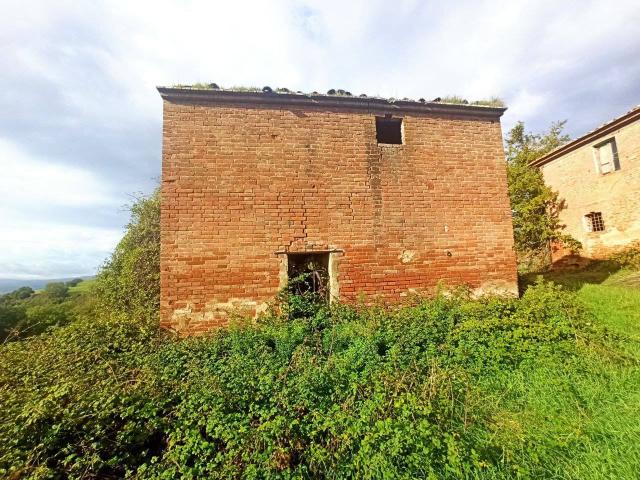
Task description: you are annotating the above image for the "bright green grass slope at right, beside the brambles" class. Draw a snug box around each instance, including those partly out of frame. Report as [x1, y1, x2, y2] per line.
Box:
[512, 263, 640, 479]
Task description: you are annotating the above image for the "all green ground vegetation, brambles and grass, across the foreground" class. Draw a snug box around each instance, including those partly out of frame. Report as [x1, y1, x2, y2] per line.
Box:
[0, 262, 640, 480]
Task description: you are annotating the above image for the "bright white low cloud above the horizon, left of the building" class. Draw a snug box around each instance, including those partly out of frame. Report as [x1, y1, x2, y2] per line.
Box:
[0, 138, 122, 278]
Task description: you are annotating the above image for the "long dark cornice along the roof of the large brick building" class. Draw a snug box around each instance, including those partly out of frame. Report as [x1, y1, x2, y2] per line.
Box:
[157, 87, 506, 119]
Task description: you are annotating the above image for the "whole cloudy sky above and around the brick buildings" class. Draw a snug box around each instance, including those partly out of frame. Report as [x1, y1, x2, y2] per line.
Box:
[0, 0, 640, 278]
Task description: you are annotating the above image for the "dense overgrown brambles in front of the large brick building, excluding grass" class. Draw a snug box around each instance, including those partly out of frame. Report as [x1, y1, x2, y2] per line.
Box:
[0, 284, 620, 478]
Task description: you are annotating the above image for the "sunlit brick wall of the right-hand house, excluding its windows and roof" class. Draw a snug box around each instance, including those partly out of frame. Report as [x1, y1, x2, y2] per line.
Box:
[542, 121, 640, 260]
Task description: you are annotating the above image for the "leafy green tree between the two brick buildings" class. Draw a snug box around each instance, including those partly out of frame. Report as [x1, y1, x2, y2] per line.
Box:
[505, 122, 581, 268]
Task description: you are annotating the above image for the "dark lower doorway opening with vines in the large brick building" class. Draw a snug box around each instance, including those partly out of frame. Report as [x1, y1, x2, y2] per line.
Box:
[287, 252, 329, 300]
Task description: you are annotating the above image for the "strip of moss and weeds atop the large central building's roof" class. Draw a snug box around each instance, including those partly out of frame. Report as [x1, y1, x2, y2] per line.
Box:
[171, 82, 505, 108]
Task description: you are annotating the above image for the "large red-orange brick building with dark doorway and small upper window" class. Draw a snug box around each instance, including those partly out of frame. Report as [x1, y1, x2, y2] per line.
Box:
[159, 88, 517, 333]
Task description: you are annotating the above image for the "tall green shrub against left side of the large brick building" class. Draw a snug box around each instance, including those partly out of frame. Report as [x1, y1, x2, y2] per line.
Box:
[95, 190, 160, 319]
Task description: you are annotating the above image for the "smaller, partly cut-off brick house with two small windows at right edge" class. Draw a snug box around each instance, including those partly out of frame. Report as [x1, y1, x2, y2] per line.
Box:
[533, 106, 640, 260]
